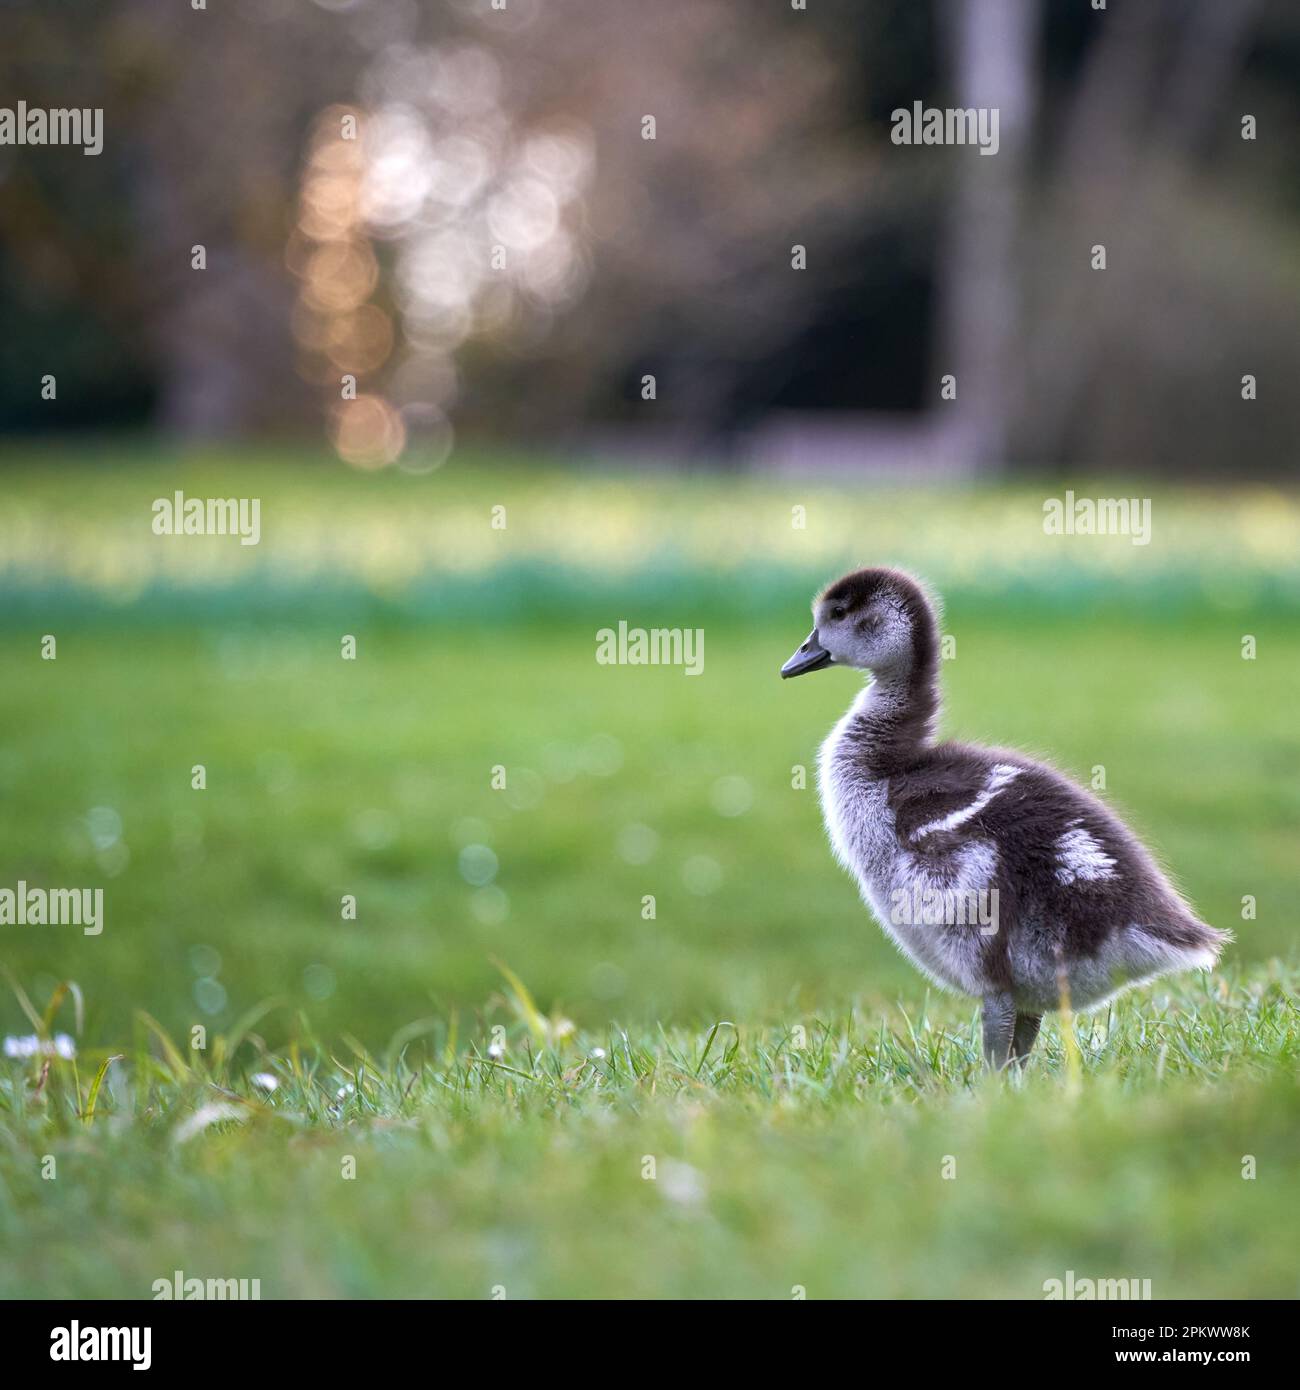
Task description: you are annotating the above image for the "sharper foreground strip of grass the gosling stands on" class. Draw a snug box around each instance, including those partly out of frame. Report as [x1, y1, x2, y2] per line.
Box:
[0, 970, 1300, 1298]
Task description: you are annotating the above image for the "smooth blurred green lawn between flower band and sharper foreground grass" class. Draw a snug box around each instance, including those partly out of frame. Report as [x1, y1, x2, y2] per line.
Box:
[0, 614, 1300, 1047]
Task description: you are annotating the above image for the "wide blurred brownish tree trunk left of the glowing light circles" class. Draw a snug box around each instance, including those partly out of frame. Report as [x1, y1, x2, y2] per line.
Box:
[113, 0, 347, 439]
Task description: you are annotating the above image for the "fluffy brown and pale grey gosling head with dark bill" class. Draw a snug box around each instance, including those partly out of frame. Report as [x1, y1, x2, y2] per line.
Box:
[781, 570, 937, 680]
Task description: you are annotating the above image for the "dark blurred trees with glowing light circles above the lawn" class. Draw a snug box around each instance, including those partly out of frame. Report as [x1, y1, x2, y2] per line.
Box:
[0, 0, 1300, 478]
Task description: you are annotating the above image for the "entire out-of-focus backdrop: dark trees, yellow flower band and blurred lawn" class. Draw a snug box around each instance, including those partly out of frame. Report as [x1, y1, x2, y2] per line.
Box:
[0, 0, 1300, 1041]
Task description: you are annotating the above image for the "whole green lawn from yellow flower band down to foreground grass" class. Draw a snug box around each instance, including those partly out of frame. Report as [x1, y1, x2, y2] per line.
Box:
[0, 450, 1300, 1297]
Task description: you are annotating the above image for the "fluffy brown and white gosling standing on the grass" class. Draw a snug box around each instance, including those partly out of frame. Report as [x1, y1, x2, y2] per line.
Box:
[781, 569, 1232, 1070]
